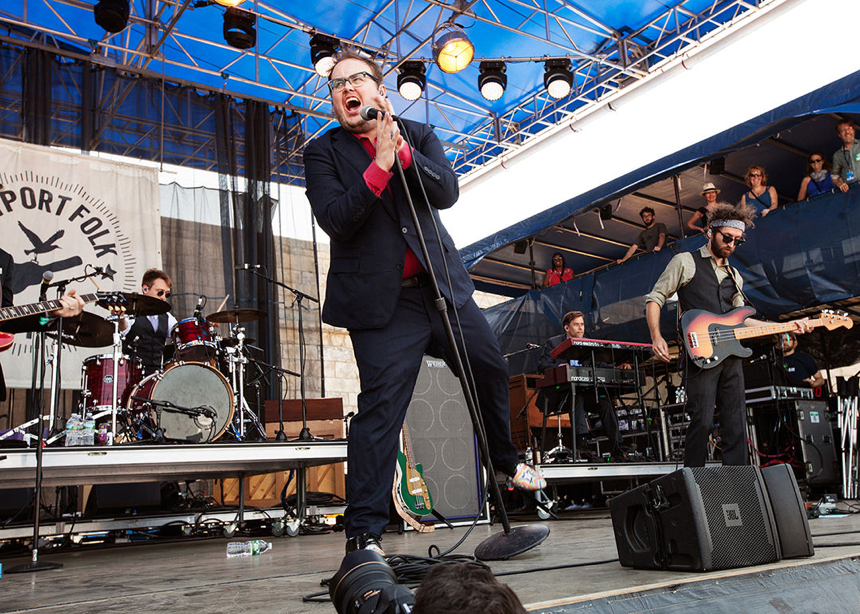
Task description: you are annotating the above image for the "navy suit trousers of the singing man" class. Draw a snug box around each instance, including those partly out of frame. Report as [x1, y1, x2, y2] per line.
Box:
[344, 286, 517, 538]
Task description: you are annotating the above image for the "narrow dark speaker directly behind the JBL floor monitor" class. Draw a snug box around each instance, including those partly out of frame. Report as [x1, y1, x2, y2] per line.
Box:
[761, 464, 815, 559]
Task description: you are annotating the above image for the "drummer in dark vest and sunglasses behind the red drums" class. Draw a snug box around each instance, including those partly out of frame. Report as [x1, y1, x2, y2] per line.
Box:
[119, 269, 176, 374]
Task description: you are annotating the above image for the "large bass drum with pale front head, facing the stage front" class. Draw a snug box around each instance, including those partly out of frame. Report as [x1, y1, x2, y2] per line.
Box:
[128, 362, 235, 443]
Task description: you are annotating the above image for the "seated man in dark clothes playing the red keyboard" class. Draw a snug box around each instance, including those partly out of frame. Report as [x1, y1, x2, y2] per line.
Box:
[537, 311, 631, 457]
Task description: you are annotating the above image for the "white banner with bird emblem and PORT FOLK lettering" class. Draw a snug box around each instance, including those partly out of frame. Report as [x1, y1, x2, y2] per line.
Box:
[0, 139, 161, 389]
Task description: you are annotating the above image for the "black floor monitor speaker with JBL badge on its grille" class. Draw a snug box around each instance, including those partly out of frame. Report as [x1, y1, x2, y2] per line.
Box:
[609, 467, 781, 571]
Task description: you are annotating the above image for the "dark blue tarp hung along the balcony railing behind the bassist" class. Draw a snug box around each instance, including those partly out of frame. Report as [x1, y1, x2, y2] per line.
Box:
[484, 185, 860, 374]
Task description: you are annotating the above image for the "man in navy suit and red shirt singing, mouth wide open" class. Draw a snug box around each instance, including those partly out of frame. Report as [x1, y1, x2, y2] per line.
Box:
[304, 51, 545, 552]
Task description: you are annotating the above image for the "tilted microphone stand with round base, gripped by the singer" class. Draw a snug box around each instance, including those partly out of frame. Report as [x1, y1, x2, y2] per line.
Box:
[394, 122, 549, 561]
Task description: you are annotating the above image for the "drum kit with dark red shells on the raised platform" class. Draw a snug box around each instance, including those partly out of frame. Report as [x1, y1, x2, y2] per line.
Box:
[76, 293, 266, 443]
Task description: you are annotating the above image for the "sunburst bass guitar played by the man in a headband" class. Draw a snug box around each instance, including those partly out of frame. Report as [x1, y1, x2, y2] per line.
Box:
[681, 307, 854, 369]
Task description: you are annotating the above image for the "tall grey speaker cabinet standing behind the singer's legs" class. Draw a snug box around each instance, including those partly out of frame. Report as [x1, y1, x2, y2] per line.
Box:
[406, 356, 482, 522]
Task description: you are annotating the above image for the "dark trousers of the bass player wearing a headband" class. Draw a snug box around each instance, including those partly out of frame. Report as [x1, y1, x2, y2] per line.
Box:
[684, 356, 747, 467]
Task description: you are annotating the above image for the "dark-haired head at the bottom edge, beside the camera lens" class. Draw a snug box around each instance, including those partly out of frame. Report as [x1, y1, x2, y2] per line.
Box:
[412, 563, 526, 614]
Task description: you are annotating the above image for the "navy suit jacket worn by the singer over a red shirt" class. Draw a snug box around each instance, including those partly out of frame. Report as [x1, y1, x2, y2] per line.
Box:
[304, 120, 474, 329]
